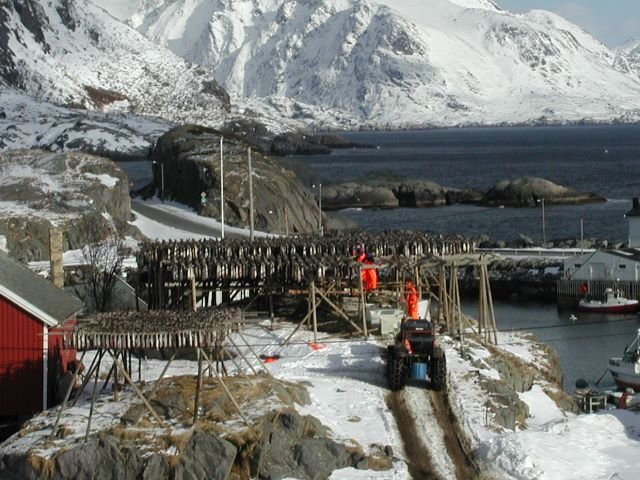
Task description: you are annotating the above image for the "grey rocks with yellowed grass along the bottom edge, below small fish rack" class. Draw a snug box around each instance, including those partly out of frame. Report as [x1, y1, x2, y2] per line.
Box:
[0, 408, 392, 480]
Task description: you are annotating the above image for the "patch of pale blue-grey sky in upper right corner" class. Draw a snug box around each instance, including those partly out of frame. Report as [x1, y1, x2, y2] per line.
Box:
[497, 0, 640, 46]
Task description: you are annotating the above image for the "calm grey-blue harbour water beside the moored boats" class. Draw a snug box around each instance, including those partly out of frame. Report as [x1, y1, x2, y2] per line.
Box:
[462, 301, 640, 392]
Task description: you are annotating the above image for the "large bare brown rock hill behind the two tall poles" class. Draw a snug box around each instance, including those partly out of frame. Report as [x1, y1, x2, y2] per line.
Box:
[151, 125, 326, 233]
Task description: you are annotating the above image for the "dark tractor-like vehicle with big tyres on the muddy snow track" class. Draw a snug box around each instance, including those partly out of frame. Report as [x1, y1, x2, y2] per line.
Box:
[387, 319, 447, 390]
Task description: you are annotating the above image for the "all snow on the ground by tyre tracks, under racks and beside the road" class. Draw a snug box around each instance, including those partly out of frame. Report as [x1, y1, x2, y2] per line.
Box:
[6, 202, 640, 480]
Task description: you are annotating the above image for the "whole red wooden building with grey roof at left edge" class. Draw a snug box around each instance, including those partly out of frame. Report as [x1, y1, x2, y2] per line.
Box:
[0, 252, 82, 418]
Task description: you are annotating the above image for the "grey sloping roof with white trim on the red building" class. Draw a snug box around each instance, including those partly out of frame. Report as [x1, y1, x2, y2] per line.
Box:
[0, 251, 83, 326]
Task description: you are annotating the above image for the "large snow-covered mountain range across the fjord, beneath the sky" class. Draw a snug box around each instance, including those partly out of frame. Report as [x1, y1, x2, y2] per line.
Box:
[95, 0, 640, 127]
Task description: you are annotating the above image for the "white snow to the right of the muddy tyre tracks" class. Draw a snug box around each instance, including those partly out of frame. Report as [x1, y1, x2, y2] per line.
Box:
[447, 334, 640, 480]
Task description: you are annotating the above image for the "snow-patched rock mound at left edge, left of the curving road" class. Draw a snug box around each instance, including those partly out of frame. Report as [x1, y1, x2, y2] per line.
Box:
[0, 150, 139, 261]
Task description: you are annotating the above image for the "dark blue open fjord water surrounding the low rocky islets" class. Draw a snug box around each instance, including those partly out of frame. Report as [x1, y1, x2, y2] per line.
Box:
[300, 125, 640, 242]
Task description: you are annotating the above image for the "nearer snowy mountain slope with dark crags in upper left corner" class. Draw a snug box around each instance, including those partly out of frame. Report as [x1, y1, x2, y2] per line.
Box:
[0, 0, 229, 125]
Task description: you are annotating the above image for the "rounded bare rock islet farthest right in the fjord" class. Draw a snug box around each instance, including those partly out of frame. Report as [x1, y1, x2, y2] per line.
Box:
[484, 177, 606, 207]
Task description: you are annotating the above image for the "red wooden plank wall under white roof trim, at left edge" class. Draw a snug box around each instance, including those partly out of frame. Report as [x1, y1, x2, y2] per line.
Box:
[0, 296, 44, 417]
